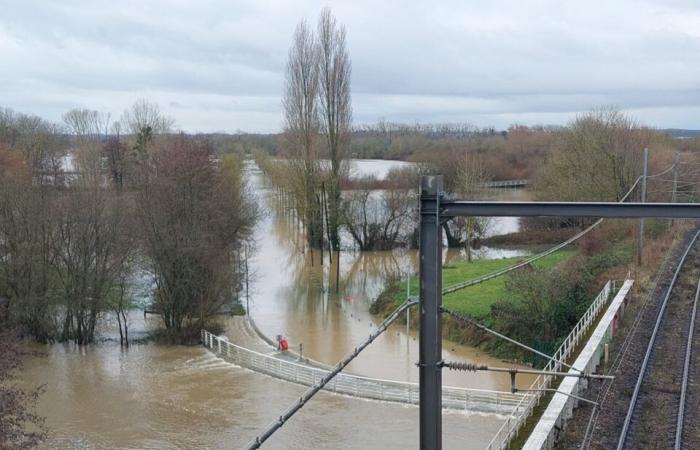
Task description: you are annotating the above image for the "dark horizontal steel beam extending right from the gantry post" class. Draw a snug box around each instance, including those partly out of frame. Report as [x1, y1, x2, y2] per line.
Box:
[440, 200, 700, 219]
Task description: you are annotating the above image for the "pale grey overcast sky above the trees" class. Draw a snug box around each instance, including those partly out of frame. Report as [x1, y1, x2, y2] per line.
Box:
[0, 0, 700, 132]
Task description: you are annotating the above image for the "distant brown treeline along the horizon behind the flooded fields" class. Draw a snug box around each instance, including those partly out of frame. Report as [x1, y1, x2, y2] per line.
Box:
[216, 121, 700, 180]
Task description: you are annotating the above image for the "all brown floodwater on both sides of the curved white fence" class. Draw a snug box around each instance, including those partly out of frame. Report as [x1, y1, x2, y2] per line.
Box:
[21, 160, 527, 449]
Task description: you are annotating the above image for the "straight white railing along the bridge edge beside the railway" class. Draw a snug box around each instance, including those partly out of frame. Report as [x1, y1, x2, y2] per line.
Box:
[486, 281, 613, 450]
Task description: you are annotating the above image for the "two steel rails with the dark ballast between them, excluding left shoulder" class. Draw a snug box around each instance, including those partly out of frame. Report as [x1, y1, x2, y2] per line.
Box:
[617, 231, 700, 450]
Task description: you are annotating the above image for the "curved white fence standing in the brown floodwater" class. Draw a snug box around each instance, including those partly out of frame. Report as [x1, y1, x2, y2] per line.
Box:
[202, 330, 526, 414]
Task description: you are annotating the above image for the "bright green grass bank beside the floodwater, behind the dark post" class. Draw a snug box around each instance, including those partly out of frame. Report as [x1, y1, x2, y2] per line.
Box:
[396, 250, 576, 318]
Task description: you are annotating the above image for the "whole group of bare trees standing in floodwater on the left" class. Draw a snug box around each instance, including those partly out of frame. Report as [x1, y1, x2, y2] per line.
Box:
[0, 100, 257, 344]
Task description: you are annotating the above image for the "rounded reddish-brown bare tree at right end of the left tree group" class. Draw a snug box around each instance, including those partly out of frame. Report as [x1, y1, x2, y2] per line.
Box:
[137, 136, 257, 335]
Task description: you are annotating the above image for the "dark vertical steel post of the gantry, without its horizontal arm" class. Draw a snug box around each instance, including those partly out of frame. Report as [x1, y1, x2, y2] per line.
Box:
[418, 175, 443, 450]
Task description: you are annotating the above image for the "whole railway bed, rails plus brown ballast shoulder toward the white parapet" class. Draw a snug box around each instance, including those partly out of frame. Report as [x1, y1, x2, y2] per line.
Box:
[580, 229, 700, 450]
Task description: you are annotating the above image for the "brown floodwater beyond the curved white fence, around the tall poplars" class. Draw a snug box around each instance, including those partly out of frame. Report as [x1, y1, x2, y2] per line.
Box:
[249, 163, 530, 390]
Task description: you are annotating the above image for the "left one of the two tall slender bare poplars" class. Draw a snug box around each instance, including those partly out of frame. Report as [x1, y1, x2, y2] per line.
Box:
[282, 20, 323, 247]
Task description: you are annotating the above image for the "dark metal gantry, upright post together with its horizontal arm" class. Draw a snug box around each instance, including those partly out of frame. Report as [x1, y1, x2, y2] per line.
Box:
[418, 175, 700, 450]
